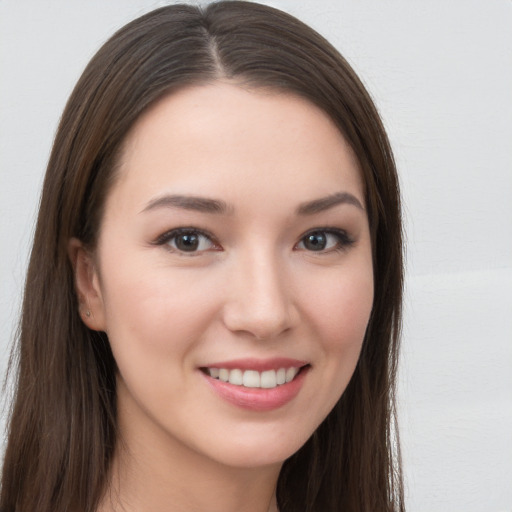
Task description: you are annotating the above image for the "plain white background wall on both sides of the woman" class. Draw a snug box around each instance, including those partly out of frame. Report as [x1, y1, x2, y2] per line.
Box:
[0, 0, 512, 512]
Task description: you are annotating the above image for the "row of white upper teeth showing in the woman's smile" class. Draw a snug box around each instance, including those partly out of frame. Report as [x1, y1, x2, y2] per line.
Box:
[207, 367, 299, 389]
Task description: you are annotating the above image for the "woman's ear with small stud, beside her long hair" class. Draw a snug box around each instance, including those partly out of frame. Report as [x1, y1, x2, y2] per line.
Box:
[68, 238, 106, 331]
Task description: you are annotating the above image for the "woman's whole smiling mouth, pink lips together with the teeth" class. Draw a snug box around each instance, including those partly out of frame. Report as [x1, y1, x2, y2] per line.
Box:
[200, 358, 310, 411]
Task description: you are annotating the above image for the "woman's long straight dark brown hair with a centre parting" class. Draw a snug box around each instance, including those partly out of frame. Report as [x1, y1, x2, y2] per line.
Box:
[0, 1, 404, 512]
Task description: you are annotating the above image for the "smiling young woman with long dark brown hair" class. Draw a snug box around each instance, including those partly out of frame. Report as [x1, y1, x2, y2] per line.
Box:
[0, 2, 403, 512]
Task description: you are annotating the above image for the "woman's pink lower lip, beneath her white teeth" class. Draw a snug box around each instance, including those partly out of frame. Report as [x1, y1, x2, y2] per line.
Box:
[201, 366, 309, 411]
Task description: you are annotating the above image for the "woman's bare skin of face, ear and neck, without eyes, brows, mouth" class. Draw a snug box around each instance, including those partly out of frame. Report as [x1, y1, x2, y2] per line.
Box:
[69, 82, 373, 512]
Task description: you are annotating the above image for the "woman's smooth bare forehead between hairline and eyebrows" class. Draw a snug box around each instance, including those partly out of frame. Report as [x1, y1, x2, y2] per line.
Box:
[113, 82, 364, 212]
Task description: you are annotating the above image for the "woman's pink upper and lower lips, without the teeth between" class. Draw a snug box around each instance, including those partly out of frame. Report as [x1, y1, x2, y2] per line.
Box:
[201, 358, 310, 411]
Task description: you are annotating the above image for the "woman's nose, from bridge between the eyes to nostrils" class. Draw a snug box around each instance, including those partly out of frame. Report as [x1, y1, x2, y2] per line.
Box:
[223, 250, 299, 340]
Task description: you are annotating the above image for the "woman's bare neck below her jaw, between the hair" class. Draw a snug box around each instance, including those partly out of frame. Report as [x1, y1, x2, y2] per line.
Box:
[98, 404, 281, 512]
